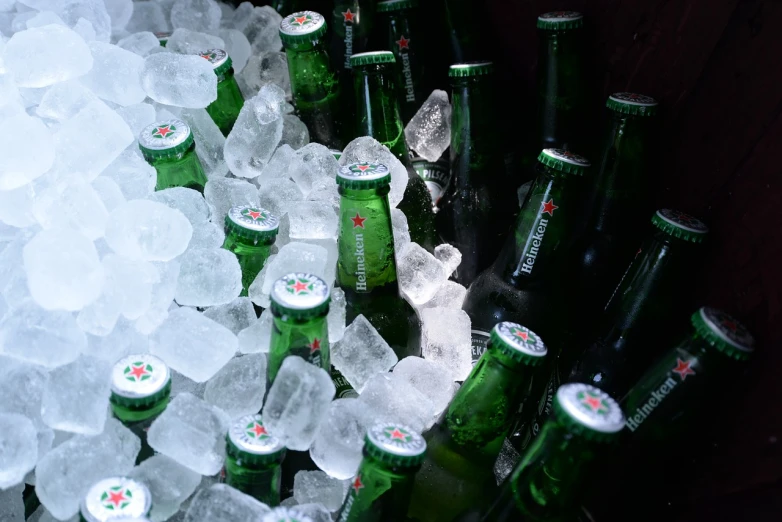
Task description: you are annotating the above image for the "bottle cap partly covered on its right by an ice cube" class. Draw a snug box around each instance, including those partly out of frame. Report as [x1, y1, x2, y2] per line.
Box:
[225, 413, 285, 465]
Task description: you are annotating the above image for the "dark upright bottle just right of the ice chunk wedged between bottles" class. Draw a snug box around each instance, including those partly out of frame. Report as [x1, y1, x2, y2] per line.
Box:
[435, 62, 519, 286]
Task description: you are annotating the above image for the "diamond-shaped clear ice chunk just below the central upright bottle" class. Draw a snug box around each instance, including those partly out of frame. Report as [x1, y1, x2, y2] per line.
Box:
[331, 315, 399, 393]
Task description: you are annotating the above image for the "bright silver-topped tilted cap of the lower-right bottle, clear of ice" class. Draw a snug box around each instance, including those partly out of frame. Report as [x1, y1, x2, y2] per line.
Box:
[554, 383, 625, 441]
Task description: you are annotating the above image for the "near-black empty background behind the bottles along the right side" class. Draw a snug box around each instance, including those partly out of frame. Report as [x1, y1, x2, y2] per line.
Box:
[254, 0, 782, 522]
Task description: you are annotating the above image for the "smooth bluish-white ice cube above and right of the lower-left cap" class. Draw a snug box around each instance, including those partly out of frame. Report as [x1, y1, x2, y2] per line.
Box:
[150, 307, 238, 382]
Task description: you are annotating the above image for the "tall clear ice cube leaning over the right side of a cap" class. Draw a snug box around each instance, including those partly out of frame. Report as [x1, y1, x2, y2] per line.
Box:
[263, 355, 336, 451]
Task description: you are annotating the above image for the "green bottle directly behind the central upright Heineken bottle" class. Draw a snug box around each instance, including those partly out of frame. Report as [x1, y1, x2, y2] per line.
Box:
[350, 51, 436, 252]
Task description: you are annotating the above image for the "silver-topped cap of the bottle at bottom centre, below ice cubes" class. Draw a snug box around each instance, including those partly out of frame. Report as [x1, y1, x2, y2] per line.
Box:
[364, 422, 426, 468]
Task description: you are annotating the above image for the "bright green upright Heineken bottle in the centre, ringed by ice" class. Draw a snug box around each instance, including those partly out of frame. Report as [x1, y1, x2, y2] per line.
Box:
[337, 163, 421, 360]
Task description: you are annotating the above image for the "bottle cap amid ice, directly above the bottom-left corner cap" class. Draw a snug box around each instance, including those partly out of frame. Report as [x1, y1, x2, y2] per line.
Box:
[111, 353, 171, 408]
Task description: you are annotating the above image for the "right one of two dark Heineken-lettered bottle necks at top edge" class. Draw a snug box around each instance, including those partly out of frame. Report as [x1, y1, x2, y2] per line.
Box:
[377, 0, 426, 123]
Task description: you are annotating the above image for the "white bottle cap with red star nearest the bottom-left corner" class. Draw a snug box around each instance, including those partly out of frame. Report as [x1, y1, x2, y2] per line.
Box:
[81, 477, 152, 522]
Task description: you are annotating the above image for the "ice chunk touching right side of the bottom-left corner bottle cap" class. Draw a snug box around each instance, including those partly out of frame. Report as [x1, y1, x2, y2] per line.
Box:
[128, 455, 201, 521]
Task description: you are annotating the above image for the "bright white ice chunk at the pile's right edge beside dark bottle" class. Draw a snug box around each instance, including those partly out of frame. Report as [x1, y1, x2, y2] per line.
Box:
[421, 307, 472, 381]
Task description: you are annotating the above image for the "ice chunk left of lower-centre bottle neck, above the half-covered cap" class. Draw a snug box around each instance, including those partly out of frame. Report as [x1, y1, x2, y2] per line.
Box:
[204, 353, 266, 418]
